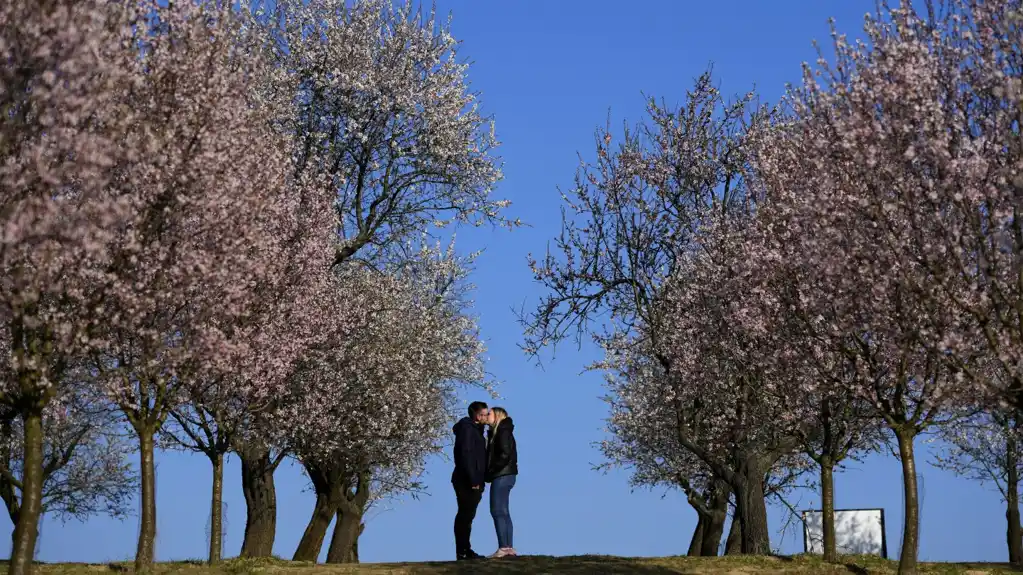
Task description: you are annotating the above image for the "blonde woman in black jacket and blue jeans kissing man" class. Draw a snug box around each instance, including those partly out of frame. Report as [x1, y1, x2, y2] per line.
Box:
[486, 407, 519, 559]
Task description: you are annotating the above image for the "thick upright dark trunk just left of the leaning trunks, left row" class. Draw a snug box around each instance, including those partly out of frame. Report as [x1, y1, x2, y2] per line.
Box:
[237, 446, 277, 558]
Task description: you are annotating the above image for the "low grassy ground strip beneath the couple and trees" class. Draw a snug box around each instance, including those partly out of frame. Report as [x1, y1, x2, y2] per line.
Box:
[6, 556, 1014, 575]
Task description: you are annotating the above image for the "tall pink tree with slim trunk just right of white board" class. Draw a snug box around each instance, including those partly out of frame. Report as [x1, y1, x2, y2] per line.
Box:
[758, 1, 1012, 573]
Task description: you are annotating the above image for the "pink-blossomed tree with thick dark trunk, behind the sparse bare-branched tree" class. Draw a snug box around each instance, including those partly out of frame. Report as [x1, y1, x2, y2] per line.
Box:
[634, 217, 813, 555]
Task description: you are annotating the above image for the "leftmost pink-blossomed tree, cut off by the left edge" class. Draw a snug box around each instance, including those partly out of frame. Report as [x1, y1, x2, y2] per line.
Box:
[0, 0, 146, 575]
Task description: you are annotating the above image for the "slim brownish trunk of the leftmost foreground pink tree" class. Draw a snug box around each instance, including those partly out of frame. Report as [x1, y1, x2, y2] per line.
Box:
[7, 409, 43, 575]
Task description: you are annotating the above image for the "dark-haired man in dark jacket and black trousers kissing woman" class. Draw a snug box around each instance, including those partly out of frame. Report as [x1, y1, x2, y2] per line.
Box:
[451, 401, 490, 561]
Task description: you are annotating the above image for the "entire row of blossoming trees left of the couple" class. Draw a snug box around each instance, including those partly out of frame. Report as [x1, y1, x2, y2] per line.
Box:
[0, 0, 514, 574]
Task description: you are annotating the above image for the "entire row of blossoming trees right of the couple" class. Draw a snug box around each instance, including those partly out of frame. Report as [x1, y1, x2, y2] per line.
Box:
[524, 0, 1023, 573]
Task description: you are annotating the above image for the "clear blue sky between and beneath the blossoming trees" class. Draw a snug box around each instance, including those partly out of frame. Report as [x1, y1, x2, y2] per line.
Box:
[0, 0, 1007, 562]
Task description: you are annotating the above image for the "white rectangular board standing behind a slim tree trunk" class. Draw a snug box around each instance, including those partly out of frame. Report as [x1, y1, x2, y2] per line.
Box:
[803, 510, 888, 559]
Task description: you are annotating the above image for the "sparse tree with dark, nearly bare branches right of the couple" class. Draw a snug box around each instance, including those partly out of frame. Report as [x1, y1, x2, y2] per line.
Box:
[521, 73, 786, 552]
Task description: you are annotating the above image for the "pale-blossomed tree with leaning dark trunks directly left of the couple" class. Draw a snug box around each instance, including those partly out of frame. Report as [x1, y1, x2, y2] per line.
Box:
[285, 242, 485, 563]
